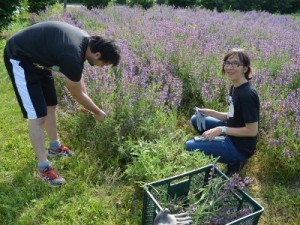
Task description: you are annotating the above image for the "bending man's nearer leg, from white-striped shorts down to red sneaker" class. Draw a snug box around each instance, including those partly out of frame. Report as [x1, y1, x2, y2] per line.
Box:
[4, 51, 65, 186]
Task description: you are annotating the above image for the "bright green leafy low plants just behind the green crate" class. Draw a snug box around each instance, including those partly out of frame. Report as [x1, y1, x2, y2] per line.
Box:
[123, 130, 215, 183]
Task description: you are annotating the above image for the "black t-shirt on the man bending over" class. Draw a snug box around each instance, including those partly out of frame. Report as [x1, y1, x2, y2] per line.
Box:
[6, 21, 89, 81]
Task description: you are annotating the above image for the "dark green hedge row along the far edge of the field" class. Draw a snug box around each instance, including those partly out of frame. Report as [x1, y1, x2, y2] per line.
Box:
[0, 0, 300, 31]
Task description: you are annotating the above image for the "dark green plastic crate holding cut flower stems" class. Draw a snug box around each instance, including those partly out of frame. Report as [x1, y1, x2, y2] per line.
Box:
[142, 164, 264, 225]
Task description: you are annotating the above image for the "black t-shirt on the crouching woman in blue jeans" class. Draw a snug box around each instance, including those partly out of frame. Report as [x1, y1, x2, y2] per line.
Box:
[227, 82, 259, 157]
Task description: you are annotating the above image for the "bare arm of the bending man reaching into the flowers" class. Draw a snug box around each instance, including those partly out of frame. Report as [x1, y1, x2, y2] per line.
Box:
[65, 77, 106, 121]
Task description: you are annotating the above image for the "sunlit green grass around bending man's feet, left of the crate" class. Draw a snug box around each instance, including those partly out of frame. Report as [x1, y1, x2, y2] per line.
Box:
[0, 21, 141, 224]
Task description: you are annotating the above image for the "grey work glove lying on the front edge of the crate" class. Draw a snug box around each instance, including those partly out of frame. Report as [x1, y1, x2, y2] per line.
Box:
[153, 209, 193, 225]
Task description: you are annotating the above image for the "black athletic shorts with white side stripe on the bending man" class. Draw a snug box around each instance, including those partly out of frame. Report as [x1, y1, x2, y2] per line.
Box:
[4, 48, 57, 119]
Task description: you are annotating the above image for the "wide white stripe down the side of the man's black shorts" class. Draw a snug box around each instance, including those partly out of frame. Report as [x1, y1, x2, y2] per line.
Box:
[10, 59, 37, 119]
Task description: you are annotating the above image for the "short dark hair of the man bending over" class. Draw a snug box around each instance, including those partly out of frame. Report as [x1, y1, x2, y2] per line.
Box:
[89, 36, 121, 66]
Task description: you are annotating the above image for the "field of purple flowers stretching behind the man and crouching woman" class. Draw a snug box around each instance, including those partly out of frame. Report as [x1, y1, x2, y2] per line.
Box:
[31, 6, 300, 178]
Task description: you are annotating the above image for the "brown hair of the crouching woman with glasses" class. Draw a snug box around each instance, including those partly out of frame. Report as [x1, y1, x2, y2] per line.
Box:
[222, 48, 252, 80]
